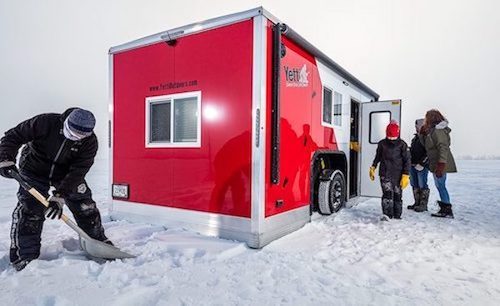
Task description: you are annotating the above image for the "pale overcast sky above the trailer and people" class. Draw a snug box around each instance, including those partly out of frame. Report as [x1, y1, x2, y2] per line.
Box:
[0, 0, 500, 157]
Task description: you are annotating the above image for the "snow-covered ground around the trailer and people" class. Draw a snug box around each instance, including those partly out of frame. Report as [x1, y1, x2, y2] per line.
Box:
[0, 161, 500, 305]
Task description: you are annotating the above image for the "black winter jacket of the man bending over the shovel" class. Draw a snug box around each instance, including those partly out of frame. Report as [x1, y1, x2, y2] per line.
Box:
[0, 108, 98, 195]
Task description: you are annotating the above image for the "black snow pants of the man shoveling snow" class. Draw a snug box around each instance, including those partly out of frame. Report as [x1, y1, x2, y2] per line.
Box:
[10, 175, 107, 263]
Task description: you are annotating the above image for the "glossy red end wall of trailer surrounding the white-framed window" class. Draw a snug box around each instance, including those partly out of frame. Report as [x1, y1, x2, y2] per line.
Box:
[113, 20, 253, 217]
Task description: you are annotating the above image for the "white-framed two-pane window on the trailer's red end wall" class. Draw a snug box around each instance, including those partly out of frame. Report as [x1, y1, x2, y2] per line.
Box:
[146, 92, 201, 148]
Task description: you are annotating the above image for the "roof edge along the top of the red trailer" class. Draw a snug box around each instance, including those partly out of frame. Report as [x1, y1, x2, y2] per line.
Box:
[109, 7, 380, 101]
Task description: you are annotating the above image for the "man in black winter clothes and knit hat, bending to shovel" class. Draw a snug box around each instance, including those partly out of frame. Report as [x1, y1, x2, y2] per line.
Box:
[0, 108, 112, 271]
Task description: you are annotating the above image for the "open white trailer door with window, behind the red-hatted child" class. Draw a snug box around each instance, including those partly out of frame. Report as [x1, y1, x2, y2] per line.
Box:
[359, 100, 401, 197]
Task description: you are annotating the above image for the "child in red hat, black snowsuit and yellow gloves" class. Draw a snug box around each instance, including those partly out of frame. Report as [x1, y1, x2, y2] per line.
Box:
[370, 120, 411, 220]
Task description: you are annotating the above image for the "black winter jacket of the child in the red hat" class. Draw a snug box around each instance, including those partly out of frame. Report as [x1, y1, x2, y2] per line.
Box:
[373, 138, 410, 184]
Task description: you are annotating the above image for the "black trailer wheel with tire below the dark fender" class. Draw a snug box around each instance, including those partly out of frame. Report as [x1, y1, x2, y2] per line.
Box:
[318, 169, 347, 215]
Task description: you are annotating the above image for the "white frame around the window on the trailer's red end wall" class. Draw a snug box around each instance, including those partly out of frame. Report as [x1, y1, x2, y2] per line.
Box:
[145, 91, 201, 148]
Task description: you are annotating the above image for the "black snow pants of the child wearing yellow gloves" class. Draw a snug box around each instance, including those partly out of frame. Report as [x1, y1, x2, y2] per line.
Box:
[380, 177, 403, 219]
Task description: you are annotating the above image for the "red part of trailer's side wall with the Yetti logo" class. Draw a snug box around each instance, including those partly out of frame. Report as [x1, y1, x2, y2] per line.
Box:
[265, 23, 337, 217]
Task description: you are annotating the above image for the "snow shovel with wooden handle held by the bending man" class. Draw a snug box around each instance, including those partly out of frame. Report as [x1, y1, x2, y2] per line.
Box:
[10, 170, 135, 259]
